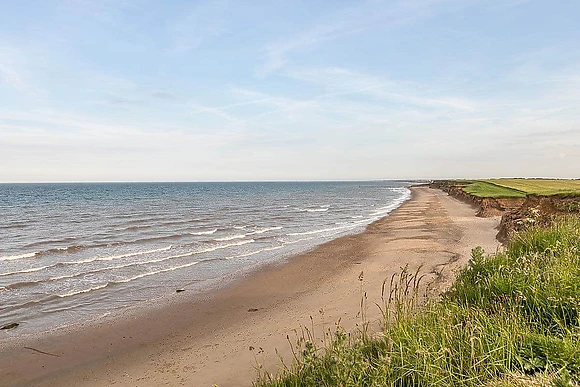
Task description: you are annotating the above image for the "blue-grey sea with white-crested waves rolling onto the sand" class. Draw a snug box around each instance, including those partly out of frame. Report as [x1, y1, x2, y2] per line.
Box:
[0, 181, 413, 340]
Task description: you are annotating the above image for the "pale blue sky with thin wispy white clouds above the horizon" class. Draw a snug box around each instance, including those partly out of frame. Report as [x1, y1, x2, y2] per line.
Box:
[0, 0, 580, 182]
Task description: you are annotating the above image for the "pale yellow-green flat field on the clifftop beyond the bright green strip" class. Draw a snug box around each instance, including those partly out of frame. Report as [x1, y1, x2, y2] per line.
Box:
[486, 179, 580, 196]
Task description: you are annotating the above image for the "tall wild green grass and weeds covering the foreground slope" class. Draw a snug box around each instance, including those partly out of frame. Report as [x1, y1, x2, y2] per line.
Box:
[255, 218, 580, 387]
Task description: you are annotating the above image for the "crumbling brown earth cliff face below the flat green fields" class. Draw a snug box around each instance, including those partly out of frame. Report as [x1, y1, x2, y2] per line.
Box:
[431, 182, 580, 243]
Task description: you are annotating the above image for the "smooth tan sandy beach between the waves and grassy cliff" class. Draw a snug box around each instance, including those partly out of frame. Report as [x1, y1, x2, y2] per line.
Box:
[0, 187, 499, 387]
